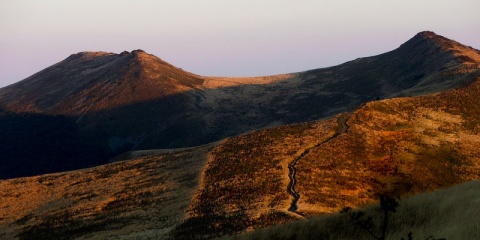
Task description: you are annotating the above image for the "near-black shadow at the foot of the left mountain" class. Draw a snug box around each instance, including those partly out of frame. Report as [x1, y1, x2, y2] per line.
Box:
[0, 112, 111, 179]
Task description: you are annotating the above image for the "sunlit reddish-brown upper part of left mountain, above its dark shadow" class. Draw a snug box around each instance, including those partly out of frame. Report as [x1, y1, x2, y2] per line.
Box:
[1, 50, 203, 115]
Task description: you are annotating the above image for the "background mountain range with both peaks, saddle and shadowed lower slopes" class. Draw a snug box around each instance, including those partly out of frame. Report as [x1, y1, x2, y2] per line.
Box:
[0, 32, 480, 178]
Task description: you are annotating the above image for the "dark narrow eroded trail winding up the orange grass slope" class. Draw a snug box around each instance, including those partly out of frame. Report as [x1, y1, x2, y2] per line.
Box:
[287, 113, 349, 212]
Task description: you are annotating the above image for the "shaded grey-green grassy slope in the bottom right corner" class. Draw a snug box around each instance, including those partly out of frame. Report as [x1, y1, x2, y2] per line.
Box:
[225, 180, 480, 240]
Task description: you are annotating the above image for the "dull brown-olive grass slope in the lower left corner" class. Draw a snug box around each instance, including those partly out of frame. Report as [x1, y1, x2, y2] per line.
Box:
[0, 144, 213, 239]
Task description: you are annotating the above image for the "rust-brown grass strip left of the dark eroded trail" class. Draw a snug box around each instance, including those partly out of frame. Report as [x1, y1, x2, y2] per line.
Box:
[174, 119, 337, 238]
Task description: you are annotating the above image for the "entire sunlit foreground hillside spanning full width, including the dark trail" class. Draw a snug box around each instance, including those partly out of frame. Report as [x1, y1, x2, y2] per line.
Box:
[0, 72, 480, 239]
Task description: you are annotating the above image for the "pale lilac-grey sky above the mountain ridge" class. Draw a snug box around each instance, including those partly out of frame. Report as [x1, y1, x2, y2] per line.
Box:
[0, 0, 480, 87]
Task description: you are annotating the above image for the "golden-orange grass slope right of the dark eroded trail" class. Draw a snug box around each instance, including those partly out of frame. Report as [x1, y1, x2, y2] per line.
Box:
[297, 78, 480, 214]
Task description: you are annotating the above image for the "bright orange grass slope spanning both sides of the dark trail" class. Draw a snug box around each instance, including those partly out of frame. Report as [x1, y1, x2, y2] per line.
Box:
[175, 76, 480, 238]
